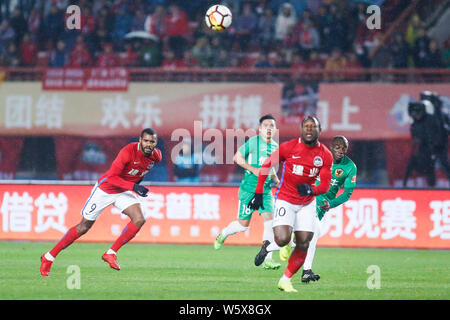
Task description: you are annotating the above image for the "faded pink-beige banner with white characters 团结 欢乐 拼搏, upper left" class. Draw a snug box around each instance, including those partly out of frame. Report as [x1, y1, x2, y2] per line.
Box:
[0, 82, 281, 137]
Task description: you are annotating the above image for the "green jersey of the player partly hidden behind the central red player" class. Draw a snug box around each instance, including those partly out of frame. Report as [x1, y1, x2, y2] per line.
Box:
[316, 156, 356, 220]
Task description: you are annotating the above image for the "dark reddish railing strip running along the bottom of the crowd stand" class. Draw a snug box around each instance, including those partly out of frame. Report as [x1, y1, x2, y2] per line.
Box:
[0, 67, 450, 83]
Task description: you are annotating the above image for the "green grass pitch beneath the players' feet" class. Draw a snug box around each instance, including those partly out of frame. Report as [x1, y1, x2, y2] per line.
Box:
[0, 242, 450, 300]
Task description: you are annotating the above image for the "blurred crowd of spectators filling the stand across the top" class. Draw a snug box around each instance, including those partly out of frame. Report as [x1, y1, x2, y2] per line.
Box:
[0, 0, 450, 69]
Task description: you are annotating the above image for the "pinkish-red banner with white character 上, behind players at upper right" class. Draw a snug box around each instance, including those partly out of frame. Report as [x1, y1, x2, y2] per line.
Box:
[280, 83, 450, 140]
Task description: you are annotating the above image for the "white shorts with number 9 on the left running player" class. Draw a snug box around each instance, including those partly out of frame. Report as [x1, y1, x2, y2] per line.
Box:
[81, 183, 141, 221]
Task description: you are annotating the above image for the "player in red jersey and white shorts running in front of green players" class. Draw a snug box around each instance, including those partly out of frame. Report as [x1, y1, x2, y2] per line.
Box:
[248, 116, 333, 292]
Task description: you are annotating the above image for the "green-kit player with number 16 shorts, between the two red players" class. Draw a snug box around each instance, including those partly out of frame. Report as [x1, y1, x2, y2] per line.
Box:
[214, 115, 281, 269]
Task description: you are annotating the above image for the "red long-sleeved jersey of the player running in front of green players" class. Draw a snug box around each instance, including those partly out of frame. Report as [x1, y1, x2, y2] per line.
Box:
[255, 138, 333, 204]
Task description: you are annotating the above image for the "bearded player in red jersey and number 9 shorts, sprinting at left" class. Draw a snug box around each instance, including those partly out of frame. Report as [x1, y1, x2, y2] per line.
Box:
[40, 128, 162, 277]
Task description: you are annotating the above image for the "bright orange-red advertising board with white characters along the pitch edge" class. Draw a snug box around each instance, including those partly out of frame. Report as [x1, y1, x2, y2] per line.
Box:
[0, 185, 450, 249]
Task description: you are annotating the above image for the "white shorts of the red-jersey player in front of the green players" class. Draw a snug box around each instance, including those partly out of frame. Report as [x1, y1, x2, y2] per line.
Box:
[273, 199, 318, 232]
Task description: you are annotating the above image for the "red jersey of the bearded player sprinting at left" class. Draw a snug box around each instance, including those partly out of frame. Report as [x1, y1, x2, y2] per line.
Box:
[98, 142, 162, 193]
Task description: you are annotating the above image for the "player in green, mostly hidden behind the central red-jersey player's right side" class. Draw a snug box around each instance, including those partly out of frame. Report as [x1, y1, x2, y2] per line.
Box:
[280, 136, 356, 282]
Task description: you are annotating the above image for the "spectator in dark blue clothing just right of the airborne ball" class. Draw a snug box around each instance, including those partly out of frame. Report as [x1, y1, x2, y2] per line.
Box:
[235, 2, 258, 51]
